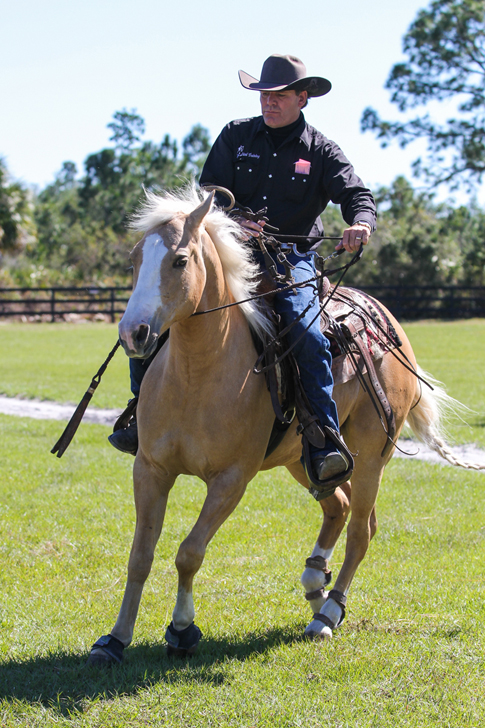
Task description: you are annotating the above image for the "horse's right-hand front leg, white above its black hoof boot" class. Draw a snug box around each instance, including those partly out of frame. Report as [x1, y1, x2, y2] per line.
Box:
[165, 467, 250, 655]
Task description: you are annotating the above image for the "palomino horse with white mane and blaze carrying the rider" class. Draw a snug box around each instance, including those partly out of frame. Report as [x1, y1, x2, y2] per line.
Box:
[89, 189, 476, 663]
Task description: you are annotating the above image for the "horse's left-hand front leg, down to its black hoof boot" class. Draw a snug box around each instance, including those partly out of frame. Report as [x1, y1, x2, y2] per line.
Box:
[88, 453, 175, 664]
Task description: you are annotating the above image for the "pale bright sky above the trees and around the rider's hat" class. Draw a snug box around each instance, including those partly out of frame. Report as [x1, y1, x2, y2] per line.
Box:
[0, 0, 474, 202]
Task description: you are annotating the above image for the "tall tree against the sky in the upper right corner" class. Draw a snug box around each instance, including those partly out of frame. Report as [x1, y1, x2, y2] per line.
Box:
[361, 0, 485, 190]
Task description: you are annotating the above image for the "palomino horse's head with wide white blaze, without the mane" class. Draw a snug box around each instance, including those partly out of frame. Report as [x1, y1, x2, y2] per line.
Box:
[119, 192, 214, 359]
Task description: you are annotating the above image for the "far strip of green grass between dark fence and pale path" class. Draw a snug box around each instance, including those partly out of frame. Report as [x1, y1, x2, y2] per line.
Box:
[0, 319, 485, 447]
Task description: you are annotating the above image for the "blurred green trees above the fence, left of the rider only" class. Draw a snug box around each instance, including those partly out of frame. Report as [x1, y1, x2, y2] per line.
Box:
[0, 109, 210, 286]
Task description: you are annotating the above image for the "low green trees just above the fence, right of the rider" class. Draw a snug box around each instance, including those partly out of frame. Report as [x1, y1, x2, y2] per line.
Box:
[322, 177, 485, 288]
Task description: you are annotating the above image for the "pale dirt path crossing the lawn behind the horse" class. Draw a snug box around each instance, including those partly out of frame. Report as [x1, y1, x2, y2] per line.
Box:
[0, 395, 485, 467]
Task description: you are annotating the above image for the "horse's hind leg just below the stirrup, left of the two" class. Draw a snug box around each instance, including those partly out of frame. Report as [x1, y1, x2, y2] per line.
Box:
[288, 462, 350, 613]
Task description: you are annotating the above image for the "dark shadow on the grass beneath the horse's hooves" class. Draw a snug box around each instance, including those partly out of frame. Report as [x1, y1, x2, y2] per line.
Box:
[0, 623, 304, 716]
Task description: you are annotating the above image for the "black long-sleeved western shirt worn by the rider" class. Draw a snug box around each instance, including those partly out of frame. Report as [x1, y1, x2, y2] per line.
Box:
[200, 114, 376, 249]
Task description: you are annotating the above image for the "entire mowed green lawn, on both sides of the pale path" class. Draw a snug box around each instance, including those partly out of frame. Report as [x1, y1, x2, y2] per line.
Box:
[0, 321, 485, 728]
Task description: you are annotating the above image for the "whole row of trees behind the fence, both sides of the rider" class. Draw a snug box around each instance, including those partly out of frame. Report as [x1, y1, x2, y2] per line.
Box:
[0, 136, 485, 286]
